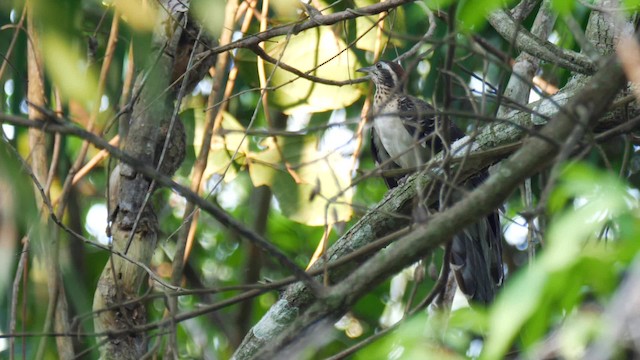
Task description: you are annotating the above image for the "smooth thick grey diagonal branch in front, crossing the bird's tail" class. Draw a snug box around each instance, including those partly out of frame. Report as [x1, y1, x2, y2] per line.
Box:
[249, 55, 625, 359]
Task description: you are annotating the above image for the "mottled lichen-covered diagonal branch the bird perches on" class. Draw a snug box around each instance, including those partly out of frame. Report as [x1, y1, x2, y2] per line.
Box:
[234, 56, 638, 359]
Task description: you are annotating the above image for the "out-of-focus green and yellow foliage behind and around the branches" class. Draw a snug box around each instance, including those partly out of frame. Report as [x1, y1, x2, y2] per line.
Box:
[0, 0, 640, 359]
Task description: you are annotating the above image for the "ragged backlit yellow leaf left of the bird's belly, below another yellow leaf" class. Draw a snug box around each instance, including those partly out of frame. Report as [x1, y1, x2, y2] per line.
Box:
[247, 136, 353, 226]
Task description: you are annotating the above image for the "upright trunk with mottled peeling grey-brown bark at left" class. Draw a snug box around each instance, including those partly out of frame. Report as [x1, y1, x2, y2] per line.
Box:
[93, 6, 185, 359]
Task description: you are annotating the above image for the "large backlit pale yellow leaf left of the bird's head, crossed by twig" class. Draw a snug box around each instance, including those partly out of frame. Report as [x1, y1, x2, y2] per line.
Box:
[266, 27, 361, 114]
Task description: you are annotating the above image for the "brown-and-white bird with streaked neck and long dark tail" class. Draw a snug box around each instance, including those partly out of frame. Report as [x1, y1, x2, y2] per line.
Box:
[357, 61, 504, 305]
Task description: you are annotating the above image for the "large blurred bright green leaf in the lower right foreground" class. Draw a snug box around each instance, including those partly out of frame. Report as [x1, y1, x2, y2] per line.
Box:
[483, 163, 637, 359]
